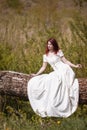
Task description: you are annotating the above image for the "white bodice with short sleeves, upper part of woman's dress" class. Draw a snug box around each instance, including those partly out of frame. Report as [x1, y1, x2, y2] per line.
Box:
[43, 50, 64, 68]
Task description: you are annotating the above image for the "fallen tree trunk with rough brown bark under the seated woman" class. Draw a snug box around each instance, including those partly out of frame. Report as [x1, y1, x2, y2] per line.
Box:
[0, 71, 87, 104]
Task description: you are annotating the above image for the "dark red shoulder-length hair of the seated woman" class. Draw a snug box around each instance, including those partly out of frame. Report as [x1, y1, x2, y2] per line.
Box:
[46, 38, 60, 54]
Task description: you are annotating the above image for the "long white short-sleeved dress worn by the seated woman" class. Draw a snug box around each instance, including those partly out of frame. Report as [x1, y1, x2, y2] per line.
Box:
[27, 50, 79, 117]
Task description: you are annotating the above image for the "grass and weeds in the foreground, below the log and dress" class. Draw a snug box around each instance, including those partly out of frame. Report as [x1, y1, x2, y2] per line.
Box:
[0, 97, 87, 130]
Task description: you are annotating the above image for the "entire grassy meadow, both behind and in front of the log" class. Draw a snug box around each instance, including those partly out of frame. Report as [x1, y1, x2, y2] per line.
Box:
[0, 0, 87, 130]
